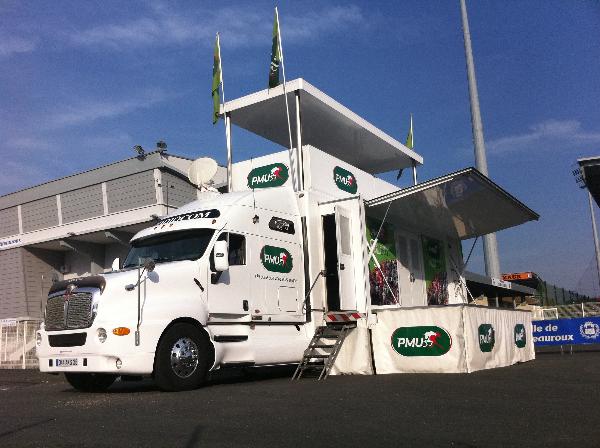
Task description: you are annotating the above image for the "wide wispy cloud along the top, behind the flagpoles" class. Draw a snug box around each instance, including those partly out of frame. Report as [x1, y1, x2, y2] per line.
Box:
[69, 4, 365, 49]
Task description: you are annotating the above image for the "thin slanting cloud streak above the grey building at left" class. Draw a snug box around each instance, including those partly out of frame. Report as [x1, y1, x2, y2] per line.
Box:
[45, 89, 174, 129]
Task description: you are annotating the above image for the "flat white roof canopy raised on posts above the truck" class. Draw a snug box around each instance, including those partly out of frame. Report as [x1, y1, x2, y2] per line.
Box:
[221, 78, 423, 174]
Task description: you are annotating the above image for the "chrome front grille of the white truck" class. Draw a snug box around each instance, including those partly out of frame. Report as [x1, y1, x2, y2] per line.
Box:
[45, 292, 92, 331]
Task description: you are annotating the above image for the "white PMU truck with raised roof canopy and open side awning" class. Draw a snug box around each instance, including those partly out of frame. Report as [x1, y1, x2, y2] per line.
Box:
[37, 79, 537, 390]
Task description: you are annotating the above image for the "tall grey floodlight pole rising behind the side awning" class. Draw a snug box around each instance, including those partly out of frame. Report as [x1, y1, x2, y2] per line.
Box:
[460, 0, 500, 278]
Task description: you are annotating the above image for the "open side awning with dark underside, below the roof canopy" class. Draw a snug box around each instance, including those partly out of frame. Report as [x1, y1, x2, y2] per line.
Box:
[365, 168, 539, 240]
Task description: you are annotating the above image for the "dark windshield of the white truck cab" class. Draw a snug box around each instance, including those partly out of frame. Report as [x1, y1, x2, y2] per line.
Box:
[123, 229, 214, 268]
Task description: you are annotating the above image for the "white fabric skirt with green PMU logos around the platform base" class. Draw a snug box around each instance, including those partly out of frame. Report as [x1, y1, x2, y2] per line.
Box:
[332, 305, 535, 375]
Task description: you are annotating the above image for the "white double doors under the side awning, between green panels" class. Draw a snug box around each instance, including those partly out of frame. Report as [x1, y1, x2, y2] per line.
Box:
[396, 230, 427, 307]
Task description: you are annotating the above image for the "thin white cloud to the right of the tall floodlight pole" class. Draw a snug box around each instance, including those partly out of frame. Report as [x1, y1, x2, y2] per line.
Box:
[486, 120, 600, 153]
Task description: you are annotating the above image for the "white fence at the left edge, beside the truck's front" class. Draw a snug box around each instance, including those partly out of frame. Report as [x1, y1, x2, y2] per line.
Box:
[0, 318, 40, 369]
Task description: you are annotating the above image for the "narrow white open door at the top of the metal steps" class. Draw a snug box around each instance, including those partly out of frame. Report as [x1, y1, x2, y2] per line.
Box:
[335, 204, 356, 310]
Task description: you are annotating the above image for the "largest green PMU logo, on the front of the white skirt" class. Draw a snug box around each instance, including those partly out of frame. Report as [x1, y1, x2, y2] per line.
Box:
[392, 326, 452, 356]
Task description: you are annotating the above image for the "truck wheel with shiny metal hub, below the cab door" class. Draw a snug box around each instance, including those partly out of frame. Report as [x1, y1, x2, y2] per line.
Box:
[154, 323, 212, 391]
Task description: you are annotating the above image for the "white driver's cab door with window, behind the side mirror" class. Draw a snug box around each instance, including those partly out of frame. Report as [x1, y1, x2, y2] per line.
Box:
[208, 232, 251, 321]
